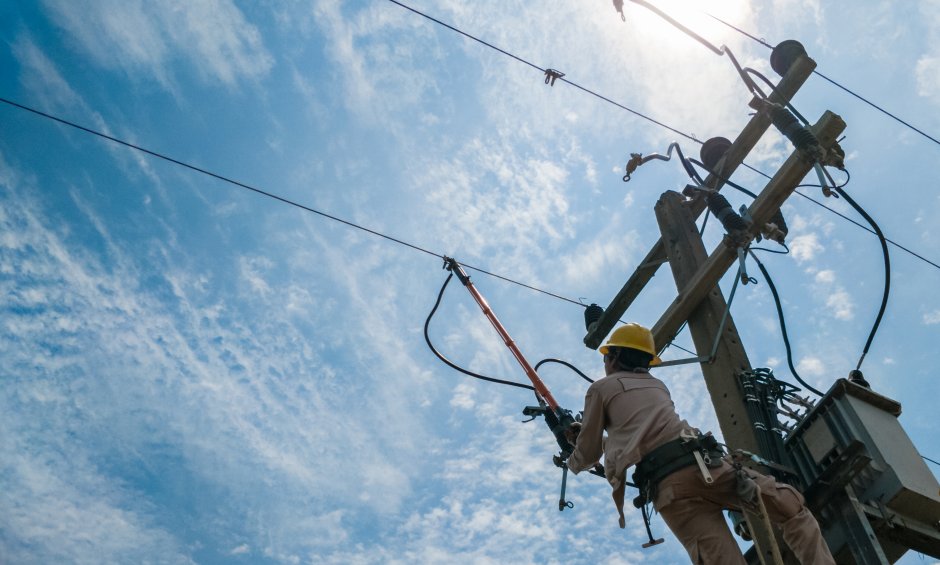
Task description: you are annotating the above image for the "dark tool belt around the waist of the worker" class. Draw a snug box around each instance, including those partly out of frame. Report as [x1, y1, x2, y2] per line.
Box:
[633, 434, 724, 508]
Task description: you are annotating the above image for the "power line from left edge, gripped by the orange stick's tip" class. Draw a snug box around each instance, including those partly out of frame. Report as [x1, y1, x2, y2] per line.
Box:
[0, 97, 585, 308]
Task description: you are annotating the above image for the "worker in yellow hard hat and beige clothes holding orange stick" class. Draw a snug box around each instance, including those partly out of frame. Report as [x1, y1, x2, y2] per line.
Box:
[567, 324, 835, 565]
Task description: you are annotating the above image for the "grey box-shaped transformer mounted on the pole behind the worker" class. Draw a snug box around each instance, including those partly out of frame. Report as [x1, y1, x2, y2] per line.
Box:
[785, 379, 940, 564]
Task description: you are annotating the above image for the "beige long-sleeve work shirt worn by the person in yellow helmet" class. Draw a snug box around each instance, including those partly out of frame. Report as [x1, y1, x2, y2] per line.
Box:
[568, 371, 694, 527]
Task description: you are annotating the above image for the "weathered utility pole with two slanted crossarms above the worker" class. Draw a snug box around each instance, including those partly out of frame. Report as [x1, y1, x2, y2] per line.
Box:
[584, 40, 845, 564]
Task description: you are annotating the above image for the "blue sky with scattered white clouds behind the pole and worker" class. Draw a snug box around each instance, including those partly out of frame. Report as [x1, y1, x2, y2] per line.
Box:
[0, 0, 940, 564]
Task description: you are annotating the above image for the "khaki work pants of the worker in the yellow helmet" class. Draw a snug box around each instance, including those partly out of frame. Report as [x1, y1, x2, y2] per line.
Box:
[654, 461, 835, 565]
